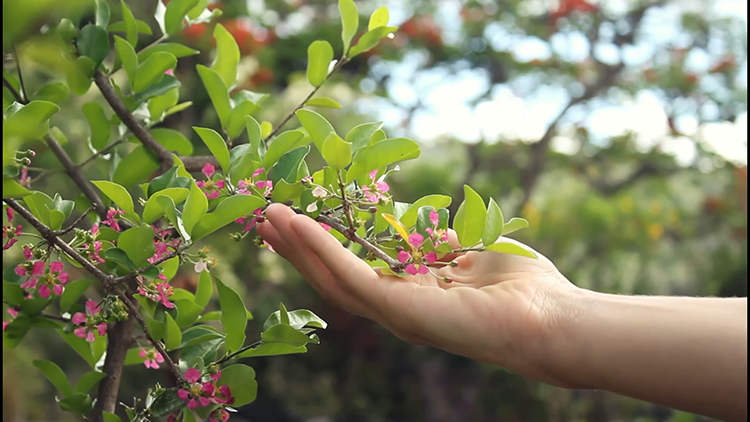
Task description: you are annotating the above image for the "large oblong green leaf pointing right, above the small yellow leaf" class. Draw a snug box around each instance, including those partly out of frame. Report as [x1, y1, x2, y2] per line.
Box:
[346, 138, 420, 184]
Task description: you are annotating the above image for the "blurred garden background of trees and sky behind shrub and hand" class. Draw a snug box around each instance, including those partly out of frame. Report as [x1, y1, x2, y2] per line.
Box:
[3, 0, 747, 422]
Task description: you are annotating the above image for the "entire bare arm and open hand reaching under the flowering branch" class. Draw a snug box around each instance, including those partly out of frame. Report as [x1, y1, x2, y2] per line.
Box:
[258, 204, 747, 421]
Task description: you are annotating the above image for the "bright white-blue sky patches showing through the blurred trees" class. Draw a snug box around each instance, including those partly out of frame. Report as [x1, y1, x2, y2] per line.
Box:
[360, 0, 747, 165]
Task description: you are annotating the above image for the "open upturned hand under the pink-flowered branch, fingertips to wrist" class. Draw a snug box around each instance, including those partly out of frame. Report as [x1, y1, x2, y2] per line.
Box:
[258, 204, 579, 387]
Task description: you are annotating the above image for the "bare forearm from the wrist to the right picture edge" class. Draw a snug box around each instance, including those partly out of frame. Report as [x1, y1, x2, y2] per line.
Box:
[558, 292, 747, 420]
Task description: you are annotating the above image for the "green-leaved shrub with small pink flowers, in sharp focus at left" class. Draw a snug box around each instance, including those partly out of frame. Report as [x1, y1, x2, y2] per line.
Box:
[3, 0, 535, 421]
